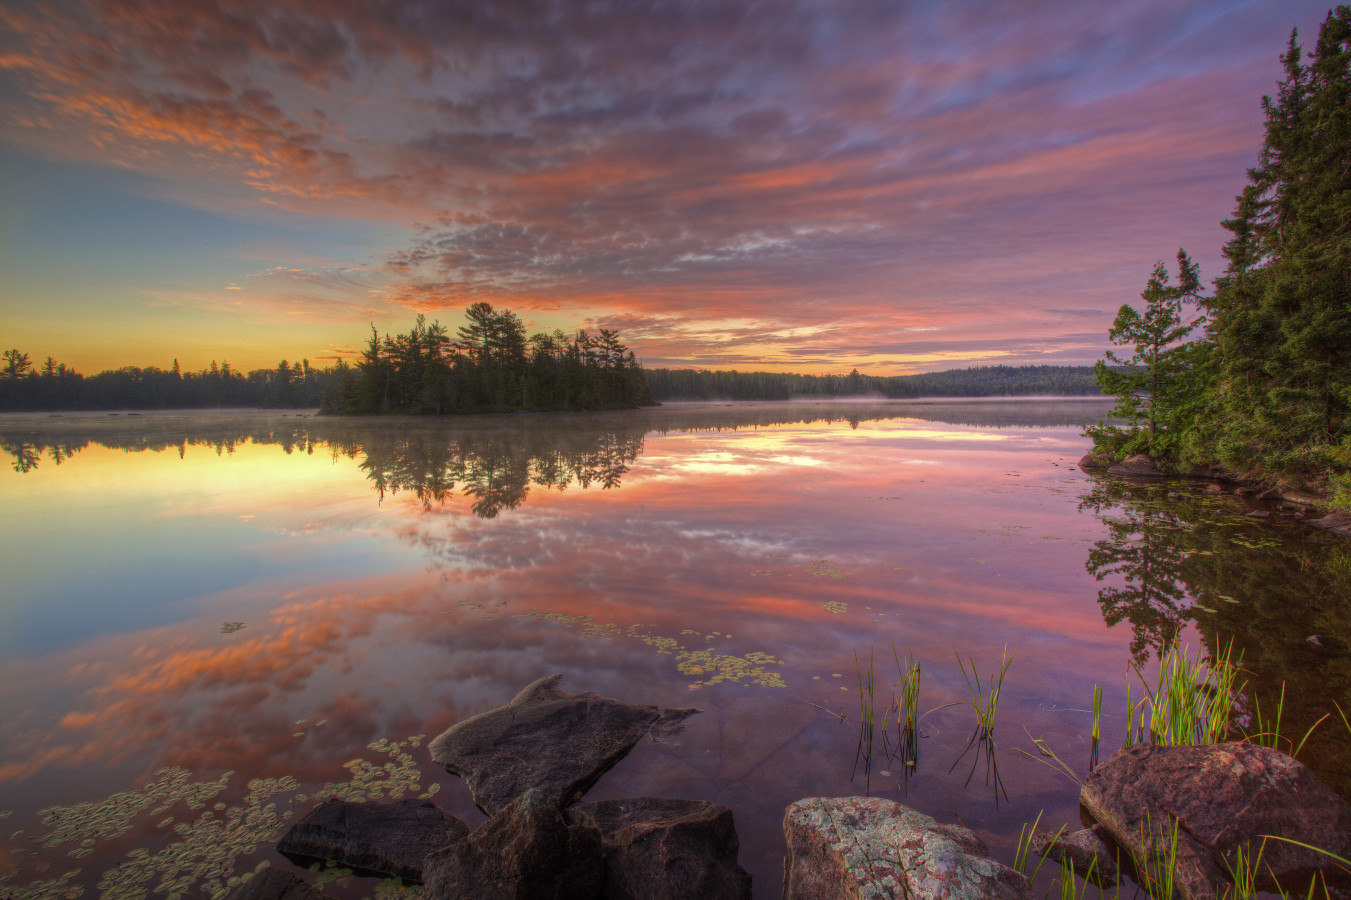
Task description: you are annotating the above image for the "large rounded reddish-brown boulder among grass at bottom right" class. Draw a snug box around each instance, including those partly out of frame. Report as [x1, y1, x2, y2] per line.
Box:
[1079, 743, 1351, 900]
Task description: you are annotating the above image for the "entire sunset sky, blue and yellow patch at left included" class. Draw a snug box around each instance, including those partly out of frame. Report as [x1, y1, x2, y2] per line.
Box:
[0, 0, 1328, 374]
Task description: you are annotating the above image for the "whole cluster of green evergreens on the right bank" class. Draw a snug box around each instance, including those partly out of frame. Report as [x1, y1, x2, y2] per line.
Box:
[1088, 5, 1351, 491]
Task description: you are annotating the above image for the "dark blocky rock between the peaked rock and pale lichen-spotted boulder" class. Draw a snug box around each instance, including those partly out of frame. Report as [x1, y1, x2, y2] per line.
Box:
[563, 797, 751, 900]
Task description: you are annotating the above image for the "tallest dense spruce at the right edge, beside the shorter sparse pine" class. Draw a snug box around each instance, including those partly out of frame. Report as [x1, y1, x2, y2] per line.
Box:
[1190, 5, 1351, 474]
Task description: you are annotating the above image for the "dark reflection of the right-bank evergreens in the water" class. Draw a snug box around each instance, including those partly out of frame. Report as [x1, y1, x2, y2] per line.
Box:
[1079, 480, 1351, 797]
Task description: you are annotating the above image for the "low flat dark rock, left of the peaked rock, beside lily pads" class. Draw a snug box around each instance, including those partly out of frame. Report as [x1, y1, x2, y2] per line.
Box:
[277, 800, 469, 884]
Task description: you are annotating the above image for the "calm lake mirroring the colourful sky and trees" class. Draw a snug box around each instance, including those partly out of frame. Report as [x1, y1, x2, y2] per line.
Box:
[0, 400, 1351, 897]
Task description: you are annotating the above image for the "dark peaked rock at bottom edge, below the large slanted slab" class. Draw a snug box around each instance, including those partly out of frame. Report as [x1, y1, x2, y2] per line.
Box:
[424, 789, 605, 900]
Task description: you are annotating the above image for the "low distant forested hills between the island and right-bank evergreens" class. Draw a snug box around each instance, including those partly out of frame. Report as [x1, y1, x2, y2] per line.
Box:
[643, 366, 1101, 401]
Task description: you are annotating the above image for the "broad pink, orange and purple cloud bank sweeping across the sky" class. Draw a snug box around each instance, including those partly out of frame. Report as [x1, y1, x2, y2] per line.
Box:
[0, 0, 1321, 361]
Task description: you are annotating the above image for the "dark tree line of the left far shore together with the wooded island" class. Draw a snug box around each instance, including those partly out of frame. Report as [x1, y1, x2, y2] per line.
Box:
[0, 303, 654, 415]
